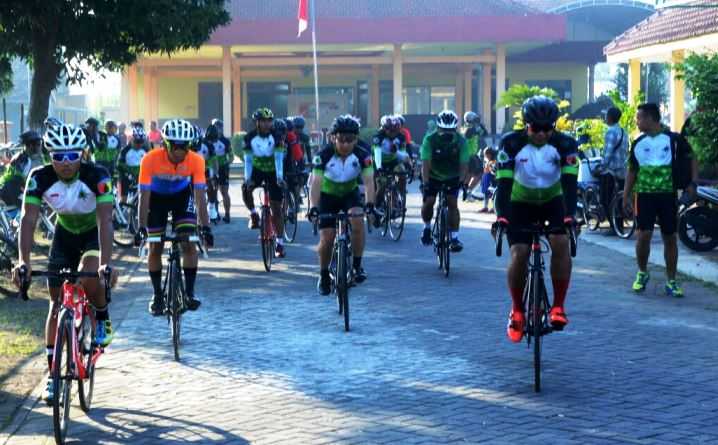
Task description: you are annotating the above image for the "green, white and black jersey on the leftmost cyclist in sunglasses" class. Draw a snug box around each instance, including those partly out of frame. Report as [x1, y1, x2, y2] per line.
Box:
[25, 162, 114, 234]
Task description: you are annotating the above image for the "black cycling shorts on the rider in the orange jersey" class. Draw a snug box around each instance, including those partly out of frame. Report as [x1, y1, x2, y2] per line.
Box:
[147, 187, 197, 236]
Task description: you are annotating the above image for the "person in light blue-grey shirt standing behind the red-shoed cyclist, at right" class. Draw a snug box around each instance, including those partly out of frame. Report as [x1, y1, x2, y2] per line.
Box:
[599, 107, 629, 233]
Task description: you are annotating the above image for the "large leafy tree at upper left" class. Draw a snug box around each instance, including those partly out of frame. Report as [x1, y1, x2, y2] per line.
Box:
[0, 0, 230, 128]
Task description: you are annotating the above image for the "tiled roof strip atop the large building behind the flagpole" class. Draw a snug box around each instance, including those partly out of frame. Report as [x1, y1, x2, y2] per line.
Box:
[228, 0, 537, 21]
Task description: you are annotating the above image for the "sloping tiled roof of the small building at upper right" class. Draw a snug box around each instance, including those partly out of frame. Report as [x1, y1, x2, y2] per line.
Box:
[603, 0, 718, 55]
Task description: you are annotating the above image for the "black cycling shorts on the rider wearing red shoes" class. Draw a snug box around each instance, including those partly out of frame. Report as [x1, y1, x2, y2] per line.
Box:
[506, 196, 566, 246]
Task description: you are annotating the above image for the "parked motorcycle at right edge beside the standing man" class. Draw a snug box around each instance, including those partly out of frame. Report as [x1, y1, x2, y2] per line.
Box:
[678, 187, 718, 252]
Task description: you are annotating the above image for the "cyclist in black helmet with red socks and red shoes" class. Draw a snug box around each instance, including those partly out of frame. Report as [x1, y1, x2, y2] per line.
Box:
[496, 96, 578, 342]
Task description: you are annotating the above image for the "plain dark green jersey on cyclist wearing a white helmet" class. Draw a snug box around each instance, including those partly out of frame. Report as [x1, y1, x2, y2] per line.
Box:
[421, 131, 469, 181]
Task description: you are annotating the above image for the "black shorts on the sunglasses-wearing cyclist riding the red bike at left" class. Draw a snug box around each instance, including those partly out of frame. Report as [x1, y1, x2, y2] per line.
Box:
[47, 224, 100, 287]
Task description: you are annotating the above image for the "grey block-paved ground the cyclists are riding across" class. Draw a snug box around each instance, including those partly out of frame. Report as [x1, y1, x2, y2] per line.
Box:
[0, 182, 718, 445]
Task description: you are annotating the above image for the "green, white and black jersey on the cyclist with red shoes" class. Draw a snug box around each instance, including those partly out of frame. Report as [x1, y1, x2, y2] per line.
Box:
[496, 131, 578, 216]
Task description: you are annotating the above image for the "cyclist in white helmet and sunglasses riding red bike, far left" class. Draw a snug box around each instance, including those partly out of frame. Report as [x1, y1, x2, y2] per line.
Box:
[13, 125, 113, 403]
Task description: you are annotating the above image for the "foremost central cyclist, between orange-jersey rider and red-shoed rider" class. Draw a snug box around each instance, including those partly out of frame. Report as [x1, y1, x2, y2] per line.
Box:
[309, 114, 374, 295]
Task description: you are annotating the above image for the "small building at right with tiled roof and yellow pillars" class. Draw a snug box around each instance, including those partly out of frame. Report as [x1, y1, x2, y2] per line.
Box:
[604, 0, 718, 131]
